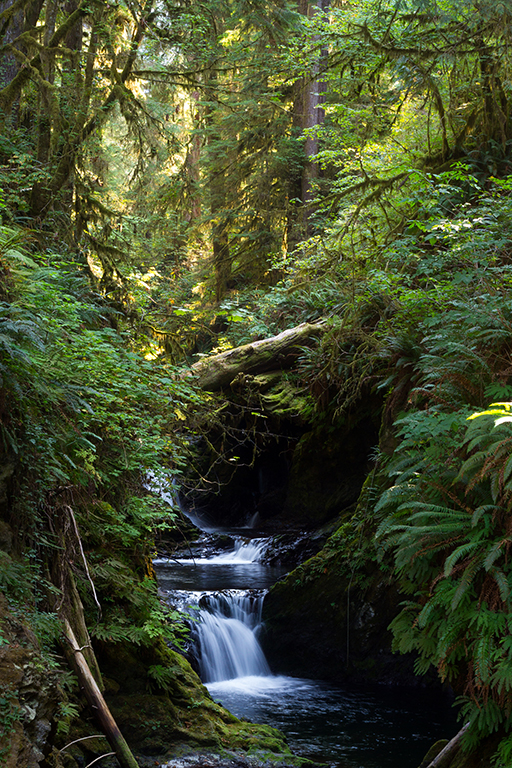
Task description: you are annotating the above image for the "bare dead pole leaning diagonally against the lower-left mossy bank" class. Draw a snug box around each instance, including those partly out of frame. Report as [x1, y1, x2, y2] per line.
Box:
[64, 619, 139, 768]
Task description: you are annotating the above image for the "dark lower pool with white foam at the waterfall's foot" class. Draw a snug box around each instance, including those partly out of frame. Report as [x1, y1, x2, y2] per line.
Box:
[207, 676, 460, 768]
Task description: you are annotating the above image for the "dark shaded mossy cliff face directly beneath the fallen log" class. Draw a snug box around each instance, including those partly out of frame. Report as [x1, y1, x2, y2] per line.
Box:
[185, 382, 382, 530]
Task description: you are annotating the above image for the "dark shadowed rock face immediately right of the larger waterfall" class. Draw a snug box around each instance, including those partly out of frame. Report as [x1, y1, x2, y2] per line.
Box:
[263, 544, 418, 685]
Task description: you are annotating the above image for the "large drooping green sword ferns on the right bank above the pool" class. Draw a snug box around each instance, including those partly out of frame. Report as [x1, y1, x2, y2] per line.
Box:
[376, 403, 512, 741]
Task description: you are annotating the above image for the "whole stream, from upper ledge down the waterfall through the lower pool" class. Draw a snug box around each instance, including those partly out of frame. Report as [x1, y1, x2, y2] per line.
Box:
[154, 534, 458, 768]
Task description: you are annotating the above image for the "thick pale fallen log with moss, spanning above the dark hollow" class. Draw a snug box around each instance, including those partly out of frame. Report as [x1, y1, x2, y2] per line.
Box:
[192, 322, 329, 392]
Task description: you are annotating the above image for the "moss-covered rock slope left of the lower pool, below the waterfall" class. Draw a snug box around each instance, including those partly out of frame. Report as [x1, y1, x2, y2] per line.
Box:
[95, 642, 293, 758]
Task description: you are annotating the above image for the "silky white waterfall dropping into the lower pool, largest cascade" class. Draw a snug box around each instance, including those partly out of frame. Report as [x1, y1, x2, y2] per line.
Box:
[195, 590, 271, 683]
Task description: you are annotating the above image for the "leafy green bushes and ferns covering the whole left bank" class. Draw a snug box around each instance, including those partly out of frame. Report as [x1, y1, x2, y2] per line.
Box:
[0, 228, 201, 733]
